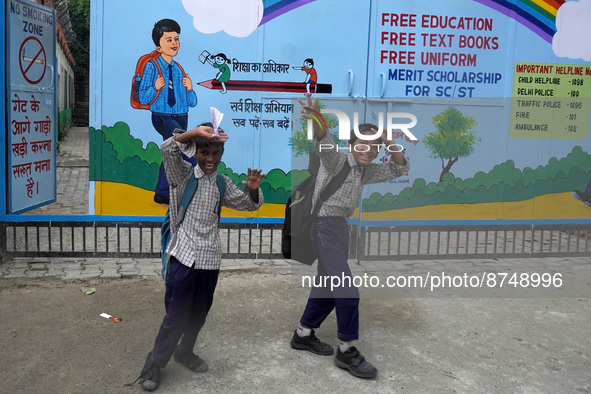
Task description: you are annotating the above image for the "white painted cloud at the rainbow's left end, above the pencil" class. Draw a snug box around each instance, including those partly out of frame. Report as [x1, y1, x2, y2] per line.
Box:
[182, 0, 263, 37]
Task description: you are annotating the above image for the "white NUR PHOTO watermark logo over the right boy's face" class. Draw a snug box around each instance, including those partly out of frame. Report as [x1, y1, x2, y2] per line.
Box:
[307, 108, 418, 153]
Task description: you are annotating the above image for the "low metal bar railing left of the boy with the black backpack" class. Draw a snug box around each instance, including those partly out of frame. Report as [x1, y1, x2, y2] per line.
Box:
[0, 221, 281, 259]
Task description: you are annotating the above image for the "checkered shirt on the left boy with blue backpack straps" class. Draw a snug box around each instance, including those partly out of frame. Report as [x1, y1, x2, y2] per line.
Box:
[161, 130, 263, 270]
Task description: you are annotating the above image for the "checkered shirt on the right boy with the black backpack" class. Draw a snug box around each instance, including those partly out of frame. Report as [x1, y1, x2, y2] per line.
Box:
[312, 133, 410, 218]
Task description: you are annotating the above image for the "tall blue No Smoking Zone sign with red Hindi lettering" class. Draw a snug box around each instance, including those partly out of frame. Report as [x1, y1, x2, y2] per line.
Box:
[6, 0, 57, 213]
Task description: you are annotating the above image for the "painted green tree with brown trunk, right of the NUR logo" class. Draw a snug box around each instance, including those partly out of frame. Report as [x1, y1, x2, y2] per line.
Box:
[423, 106, 480, 182]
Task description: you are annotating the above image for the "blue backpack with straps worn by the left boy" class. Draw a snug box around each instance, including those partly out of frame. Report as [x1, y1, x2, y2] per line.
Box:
[160, 174, 226, 284]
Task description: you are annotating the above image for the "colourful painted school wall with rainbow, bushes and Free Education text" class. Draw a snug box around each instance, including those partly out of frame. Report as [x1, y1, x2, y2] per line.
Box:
[90, 0, 591, 221]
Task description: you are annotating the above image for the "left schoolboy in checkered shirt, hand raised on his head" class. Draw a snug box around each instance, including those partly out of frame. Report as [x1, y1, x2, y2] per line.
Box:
[139, 123, 265, 391]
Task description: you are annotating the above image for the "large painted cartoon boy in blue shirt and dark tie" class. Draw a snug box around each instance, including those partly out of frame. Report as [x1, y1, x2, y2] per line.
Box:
[139, 19, 197, 204]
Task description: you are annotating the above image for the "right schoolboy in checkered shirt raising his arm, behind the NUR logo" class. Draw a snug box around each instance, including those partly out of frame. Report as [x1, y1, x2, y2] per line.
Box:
[291, 93, 410, 378]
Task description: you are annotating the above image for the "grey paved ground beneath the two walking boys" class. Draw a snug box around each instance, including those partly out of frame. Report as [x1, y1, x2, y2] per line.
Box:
[0, 270, 591, 394]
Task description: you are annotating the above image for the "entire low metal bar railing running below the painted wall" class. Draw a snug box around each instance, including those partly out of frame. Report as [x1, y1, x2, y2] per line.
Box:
[0, 221, 591, 261]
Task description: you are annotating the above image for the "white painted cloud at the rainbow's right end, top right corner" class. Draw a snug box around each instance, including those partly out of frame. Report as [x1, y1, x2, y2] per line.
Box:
[552, 0, 591, 61]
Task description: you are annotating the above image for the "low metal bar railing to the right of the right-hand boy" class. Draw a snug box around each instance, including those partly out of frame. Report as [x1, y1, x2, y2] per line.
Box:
[357, 224, 591, 260]
